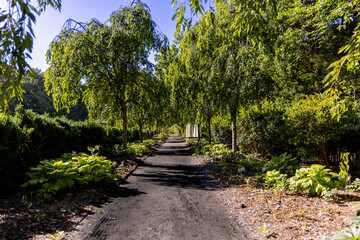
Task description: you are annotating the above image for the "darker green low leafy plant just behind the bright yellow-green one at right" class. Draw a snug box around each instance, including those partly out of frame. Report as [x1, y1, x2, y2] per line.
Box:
[263, 153, 300, 175]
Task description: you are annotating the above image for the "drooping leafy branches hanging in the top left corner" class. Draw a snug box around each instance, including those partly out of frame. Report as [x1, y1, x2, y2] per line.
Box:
[0, 0, 61, 111]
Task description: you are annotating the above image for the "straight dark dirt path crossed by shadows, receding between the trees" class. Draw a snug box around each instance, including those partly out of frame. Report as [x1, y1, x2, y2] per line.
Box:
[69, 136, 249, 240]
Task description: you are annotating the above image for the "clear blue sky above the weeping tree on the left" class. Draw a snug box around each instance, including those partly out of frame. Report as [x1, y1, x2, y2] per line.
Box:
[10, 0, 190, 71]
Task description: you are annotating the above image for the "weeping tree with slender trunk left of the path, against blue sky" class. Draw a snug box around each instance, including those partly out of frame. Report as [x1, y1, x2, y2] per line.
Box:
[45, 3, 166, 148]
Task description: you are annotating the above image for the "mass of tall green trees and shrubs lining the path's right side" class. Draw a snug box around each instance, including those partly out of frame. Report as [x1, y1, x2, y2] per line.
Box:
[159, 1, 360, 167]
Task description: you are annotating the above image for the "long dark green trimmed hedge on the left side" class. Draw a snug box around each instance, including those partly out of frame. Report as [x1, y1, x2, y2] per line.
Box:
[0, 106, 122, 194]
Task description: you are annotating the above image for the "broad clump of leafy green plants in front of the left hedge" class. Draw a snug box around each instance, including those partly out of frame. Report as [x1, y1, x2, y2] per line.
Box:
[21, 148, 118, 201]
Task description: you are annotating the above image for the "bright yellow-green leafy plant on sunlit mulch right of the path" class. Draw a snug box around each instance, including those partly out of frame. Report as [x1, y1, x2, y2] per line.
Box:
[289, 164, 341, 196]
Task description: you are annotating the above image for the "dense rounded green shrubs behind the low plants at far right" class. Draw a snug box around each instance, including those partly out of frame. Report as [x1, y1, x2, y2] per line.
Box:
[238, 95, 360, 166]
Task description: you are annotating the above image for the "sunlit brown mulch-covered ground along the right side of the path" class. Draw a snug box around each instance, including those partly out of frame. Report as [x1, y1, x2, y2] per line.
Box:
[199, 157, 360, 240]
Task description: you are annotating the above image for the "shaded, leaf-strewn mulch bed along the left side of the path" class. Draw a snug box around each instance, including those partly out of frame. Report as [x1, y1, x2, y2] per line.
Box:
[0, 181, 145, 239]
